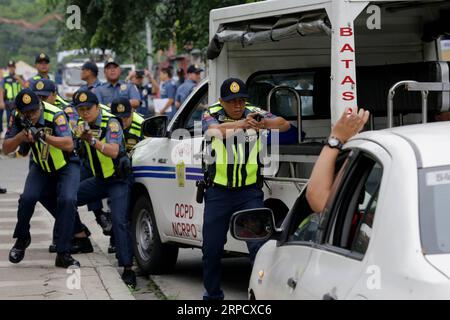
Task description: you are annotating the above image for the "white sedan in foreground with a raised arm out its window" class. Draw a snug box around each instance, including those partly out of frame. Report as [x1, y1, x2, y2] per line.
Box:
[232, 122, 450, 299]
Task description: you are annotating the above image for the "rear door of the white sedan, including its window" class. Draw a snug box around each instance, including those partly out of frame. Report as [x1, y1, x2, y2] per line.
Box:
[296, 142, 389, 300]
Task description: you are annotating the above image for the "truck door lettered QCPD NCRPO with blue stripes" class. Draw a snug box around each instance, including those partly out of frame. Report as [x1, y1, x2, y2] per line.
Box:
[147, 82, 208, 245]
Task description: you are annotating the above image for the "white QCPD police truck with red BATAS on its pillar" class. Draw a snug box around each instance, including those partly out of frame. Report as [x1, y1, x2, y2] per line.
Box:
[132, 0, 450, 273]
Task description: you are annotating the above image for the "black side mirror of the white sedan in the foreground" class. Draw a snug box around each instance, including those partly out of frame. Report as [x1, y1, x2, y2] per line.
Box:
[230, 208, 276, 241]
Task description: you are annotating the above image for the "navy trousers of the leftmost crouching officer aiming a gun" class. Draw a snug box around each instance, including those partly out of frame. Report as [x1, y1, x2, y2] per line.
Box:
[14, 160, 80, 253]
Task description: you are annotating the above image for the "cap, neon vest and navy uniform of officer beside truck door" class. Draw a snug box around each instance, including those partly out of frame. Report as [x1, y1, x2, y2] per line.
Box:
[202, 78, 275, 300]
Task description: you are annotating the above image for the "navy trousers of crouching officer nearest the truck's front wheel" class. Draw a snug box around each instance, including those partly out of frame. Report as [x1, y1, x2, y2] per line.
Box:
[75, 177, 133, 267]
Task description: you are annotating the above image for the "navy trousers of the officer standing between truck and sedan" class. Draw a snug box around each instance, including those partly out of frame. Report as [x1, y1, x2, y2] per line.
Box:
[202, 186, 264, 300]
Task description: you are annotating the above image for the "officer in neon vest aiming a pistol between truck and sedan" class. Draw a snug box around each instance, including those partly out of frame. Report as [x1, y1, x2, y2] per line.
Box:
[202, 78, 290, 300]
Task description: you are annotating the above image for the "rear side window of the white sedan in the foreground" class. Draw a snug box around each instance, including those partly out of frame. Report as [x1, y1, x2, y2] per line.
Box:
[326, 153, 383, 256]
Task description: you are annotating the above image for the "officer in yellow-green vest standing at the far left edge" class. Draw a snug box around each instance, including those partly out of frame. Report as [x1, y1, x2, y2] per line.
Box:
[0, 60, 24, 133]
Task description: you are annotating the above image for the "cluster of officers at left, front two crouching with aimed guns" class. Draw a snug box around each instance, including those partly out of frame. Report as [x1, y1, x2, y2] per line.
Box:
[0, 53, 165, 287]
